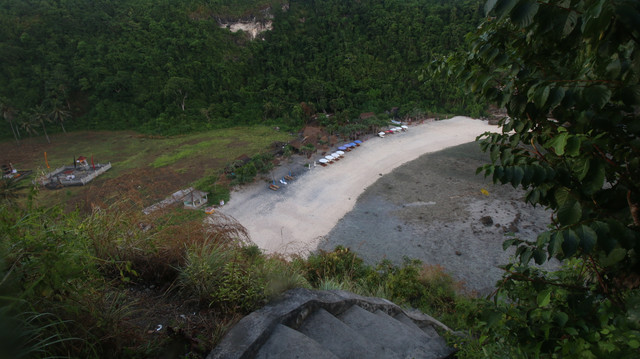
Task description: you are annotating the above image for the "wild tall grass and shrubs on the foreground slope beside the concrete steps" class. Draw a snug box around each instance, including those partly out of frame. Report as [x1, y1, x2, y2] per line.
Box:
[0, 195, 471, 357]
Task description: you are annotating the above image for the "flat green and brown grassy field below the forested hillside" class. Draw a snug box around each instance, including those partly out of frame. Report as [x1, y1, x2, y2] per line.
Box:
[0, 126, 292, 211]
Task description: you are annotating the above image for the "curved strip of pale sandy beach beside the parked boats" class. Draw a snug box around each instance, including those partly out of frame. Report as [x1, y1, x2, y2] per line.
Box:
[220, 116, 497, 255]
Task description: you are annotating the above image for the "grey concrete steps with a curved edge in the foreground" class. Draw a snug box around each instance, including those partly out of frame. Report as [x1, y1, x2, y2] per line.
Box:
[207, 288, 453, 359]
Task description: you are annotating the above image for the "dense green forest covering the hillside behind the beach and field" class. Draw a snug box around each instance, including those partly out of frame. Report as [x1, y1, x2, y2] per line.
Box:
[0, 0, 482, 138]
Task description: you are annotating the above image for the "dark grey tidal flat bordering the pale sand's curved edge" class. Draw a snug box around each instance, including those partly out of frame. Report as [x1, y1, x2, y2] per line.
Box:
[318, 142, 550, 295]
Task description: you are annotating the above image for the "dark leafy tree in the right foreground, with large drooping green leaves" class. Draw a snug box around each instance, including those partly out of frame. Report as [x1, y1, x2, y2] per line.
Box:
[450, 0, 640, 358]
